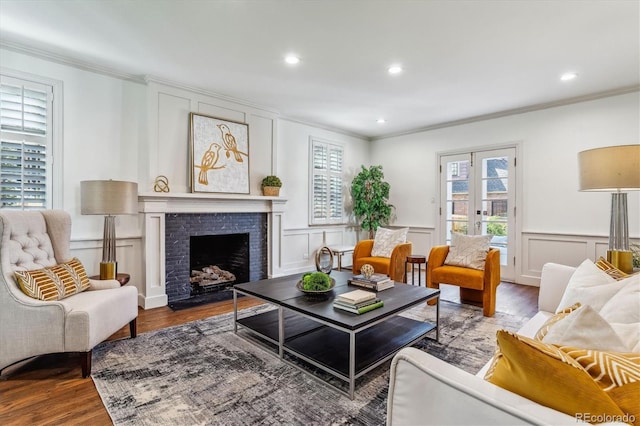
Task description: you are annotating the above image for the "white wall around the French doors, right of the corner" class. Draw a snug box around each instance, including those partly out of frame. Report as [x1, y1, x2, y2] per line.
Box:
[371, 92, 640, 282]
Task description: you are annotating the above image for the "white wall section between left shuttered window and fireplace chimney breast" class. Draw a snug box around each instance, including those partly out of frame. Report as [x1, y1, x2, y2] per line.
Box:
[0, 49, 147, 286]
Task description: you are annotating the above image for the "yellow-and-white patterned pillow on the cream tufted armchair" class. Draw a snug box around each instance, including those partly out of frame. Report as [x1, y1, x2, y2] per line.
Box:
[15, 257, 91, 300]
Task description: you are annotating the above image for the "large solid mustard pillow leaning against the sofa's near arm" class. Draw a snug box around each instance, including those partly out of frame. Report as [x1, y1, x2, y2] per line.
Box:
[485, 330, 625, 421]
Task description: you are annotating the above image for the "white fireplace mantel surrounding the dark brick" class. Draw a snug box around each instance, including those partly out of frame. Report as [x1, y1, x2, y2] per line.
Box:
[138, 192, 287, 309]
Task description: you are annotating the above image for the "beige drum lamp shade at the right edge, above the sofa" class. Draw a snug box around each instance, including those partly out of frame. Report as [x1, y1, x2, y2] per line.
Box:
[578, 144, 640, 191]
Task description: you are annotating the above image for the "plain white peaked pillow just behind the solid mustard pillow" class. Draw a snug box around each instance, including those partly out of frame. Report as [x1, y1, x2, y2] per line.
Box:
[542, 306, 633, 352]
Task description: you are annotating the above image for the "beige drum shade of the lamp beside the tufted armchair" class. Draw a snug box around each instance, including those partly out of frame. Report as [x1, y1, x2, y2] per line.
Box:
[80, 180, 138, 215]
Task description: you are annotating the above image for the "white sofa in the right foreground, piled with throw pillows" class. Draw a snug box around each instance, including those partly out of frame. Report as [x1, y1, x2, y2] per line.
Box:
[387, 263, 604, 426]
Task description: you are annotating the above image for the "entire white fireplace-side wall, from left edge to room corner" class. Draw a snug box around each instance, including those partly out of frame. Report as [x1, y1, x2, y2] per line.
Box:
[0, 49, 369, 288]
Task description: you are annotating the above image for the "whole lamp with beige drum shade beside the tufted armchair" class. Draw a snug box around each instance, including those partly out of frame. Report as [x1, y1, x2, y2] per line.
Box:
[80, 180, 138, 280]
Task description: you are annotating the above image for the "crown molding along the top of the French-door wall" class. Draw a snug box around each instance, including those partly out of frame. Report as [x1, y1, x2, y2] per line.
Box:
[370, 84, 640, 141]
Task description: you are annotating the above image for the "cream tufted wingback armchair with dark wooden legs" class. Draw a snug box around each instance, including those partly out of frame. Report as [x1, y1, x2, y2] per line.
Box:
[0, 210, 138, 377]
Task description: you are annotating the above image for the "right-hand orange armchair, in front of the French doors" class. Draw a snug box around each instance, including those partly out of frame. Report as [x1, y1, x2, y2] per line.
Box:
[427, 246, 500, 317]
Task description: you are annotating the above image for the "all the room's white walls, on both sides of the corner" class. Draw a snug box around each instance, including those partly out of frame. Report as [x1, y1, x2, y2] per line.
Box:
[0, 49, 640, 292]
